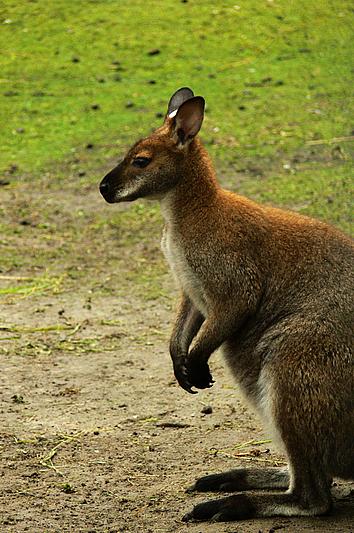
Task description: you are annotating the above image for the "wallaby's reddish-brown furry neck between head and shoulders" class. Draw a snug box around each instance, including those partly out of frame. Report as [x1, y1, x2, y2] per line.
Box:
[161, 138, 220, 222]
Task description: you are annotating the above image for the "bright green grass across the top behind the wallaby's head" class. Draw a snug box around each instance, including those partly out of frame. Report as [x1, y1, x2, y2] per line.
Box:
[0, 0, 354, 171]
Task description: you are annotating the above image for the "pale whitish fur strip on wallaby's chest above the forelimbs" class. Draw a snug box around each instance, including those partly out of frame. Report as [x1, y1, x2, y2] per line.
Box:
[161, 226, 207, 316]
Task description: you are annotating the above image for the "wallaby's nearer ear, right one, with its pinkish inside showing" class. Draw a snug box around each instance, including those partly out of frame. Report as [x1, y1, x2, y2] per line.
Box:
[173, 96, 205, 145]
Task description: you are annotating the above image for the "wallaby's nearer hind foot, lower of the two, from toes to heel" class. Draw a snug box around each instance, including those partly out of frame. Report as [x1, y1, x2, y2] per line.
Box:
[182, 493, 331, 522]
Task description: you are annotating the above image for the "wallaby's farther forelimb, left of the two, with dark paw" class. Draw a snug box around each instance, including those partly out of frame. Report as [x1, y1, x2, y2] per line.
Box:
[170, 294, 204, 393]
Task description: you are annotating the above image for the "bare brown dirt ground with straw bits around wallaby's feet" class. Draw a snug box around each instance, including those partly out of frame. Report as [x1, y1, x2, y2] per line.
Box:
[0, 175, 354, 533]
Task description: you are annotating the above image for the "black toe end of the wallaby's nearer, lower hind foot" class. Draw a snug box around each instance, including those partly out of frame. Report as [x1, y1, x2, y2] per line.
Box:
[182, 494, 255, 522]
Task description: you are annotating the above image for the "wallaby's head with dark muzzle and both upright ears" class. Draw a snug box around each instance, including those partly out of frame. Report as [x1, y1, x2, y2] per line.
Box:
[100, 87, 205, 203]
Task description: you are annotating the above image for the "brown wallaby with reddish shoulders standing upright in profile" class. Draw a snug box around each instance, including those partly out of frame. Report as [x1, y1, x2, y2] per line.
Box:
[100, 88, 354, 521]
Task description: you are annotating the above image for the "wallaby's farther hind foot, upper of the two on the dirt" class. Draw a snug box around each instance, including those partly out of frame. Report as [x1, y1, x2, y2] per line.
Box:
[187, 468, 289, 492]
